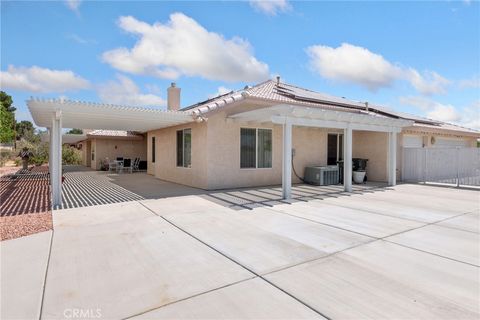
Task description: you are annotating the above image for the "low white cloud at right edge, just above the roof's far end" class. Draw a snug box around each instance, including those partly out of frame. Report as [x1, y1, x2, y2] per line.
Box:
[400, 96, 480, 129]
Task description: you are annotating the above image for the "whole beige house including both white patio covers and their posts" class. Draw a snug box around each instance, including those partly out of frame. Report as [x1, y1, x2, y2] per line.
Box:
[27, 78, 480, 205]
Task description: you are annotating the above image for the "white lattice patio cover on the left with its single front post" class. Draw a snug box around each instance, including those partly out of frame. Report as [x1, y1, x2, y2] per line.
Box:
[27, 98, 195, 208]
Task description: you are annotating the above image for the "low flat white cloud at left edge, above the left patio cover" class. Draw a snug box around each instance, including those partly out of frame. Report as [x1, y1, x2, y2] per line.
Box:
[0, 65, 90, 93]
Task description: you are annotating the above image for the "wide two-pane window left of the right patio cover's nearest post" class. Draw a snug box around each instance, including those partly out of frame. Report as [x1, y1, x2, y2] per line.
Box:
[240, 128, 272, 169]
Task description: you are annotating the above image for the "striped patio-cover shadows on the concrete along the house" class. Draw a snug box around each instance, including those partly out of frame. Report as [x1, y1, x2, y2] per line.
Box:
[62, 166, 386, 210]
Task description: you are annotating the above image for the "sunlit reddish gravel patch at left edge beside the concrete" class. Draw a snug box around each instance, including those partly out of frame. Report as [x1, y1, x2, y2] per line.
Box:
[0, 211, 53, 241]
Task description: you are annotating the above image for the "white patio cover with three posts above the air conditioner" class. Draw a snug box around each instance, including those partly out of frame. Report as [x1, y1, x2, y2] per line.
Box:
[228, 104, 413, 199]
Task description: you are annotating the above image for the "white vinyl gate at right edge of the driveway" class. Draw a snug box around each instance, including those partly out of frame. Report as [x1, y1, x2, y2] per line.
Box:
[402, 147, 480, 186]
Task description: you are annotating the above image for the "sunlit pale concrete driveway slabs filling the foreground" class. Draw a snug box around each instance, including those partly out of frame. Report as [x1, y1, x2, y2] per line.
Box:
[1, 185, 480, 319]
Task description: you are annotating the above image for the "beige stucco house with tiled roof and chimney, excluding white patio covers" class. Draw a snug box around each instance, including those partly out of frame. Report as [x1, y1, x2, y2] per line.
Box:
[147, 80, 480, 189]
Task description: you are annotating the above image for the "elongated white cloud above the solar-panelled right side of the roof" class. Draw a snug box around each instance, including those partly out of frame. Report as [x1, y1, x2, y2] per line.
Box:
[307, 43, 450, 95]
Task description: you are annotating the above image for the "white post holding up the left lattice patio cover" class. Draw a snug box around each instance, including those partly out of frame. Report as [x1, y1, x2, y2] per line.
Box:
[49, 111, 62, 208]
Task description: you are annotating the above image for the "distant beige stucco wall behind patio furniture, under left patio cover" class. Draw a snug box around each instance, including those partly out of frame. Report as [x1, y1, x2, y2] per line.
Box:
[90, 139, 147, 170]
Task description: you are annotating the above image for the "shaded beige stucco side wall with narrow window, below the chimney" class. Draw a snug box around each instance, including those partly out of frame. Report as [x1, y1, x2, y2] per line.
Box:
[147, 122, 208, 189]
